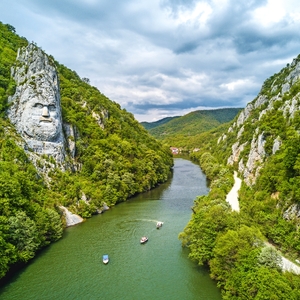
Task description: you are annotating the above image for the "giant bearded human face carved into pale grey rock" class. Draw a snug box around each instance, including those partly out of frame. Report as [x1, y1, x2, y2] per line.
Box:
[20, 86, 62, 142]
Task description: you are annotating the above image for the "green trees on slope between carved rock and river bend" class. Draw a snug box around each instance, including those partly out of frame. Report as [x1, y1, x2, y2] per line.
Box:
[53, 64, 173, 209]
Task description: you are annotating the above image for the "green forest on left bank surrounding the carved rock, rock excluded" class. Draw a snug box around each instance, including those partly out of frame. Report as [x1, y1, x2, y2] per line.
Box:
[0, 23, 173, 278]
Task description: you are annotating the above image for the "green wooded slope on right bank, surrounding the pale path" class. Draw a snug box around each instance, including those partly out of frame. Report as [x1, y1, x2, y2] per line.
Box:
[180, 56, 300, 300]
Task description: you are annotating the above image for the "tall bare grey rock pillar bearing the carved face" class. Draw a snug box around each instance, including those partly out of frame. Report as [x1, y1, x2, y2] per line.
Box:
[8, 44, 65, 164]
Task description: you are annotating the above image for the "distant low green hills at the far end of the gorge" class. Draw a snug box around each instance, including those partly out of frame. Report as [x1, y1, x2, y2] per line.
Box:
[141, 108, 241, 151]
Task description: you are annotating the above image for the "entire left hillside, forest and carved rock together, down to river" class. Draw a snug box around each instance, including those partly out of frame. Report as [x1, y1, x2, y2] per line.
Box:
[0, 22, 173, 278]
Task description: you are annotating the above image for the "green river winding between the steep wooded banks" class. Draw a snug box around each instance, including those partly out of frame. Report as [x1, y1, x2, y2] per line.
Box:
[0, 158, 221, 300]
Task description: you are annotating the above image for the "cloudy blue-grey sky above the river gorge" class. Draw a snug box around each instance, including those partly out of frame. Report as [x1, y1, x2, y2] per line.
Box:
[0, 0, 300, 122]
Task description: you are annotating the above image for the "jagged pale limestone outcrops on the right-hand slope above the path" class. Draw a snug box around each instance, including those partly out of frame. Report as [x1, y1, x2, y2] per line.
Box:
[218, 58, 300, 185]
